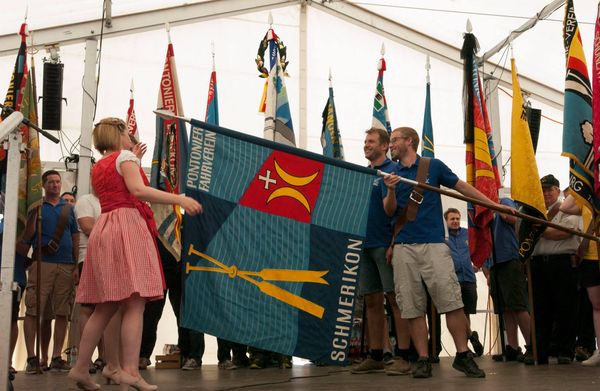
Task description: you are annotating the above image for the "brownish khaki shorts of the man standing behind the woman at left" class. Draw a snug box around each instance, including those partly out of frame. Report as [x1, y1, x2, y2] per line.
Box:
[25, 262, 76, 319]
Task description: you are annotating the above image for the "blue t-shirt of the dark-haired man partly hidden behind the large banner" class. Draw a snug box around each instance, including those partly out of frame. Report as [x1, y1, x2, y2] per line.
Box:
[363, 159, 398, 248]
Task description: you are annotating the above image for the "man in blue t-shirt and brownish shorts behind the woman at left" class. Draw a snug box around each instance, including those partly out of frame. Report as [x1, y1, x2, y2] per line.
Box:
[21, 170, 79, 374]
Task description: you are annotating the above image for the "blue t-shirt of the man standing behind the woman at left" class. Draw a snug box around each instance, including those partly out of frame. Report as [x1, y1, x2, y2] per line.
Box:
[33, 200, 78, 263]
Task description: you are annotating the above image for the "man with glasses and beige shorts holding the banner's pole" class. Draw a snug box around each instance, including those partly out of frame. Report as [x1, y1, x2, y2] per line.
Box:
[383, 127, 513, 378]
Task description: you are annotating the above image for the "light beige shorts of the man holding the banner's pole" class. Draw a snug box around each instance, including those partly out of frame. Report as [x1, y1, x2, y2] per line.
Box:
[392, 243, 463, 319]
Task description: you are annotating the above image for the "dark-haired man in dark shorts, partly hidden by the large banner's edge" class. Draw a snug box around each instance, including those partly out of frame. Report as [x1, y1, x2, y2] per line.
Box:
[351, 128, 410, 375]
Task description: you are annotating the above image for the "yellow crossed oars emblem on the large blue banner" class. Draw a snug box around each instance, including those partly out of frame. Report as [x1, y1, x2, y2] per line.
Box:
[185, 244, 329, 319]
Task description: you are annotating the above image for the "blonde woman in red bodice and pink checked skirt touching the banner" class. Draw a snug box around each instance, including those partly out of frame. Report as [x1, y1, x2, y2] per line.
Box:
[69, 118, 202, 391]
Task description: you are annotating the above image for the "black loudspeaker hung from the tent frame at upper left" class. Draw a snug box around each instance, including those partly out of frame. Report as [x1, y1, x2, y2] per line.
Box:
[42, 62, 64, 130]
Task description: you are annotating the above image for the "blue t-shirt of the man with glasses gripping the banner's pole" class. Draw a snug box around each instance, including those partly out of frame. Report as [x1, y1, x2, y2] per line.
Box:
[381, 155, 458, 244]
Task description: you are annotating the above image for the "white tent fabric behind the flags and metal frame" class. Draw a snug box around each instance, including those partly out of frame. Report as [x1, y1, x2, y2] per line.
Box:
[0, 0, 597, 370]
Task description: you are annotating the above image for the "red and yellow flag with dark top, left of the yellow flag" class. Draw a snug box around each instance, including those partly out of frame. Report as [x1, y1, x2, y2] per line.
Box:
[461, 33, 500, 267]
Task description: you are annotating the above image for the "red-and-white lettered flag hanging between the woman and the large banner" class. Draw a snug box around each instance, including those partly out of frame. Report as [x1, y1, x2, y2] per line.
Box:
[150, 32, 188, 260]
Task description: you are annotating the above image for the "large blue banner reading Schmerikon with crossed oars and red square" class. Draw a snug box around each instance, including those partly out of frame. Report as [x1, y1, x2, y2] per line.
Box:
[182, 120, 375, 365]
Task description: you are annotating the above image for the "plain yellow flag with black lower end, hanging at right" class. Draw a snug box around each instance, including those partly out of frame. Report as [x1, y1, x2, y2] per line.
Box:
[510, 58, 546, 262]
